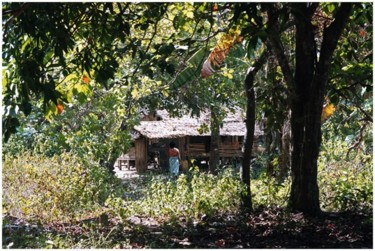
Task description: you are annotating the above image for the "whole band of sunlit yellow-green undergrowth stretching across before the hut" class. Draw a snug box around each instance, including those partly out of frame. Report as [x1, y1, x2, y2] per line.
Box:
[3, 132, 373, 226]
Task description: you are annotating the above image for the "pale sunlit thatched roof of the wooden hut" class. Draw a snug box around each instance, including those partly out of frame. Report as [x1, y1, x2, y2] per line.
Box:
[134, 108, 261, 139]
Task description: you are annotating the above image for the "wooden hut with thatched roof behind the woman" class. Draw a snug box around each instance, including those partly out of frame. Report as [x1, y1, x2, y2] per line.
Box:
[122, 110, 262, 172]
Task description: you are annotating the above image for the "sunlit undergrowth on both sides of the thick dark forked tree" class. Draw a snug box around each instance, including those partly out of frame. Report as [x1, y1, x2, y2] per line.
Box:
[251, 135, 373, 212]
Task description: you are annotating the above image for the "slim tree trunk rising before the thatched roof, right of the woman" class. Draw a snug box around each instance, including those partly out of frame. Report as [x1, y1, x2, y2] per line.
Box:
[210, 109, 220, 174]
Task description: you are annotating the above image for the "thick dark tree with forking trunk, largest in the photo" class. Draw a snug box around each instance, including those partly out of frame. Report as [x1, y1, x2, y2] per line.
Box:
[265, 3, 352, 214]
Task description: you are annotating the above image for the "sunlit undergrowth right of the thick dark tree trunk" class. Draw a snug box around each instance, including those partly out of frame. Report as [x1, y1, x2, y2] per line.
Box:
[318, 137, 373, 211]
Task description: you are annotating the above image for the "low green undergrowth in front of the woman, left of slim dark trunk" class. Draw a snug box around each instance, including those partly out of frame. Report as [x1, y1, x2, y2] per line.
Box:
[107, 168, 244, 221]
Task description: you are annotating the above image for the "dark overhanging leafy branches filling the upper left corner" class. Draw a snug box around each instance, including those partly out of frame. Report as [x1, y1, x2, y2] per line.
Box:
[3, 3, 194, 139]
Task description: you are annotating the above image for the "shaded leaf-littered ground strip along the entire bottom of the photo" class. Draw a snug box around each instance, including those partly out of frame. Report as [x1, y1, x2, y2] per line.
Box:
[2, 208, 373, 249]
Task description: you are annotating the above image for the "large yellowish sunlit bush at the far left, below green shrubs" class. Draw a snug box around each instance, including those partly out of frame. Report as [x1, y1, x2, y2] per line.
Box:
[2, 152, 125, 223]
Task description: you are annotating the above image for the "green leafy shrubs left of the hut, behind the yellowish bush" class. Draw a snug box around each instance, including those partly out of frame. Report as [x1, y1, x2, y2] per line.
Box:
[3, 84, 137, 174]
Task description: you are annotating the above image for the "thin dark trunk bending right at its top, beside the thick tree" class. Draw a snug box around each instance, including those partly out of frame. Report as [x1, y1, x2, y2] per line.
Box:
[241, 50, 268, 210]
